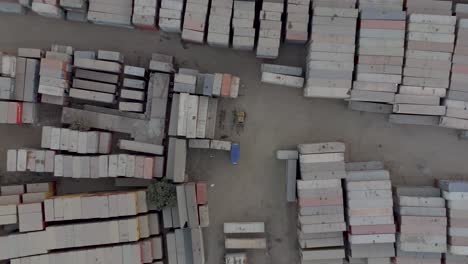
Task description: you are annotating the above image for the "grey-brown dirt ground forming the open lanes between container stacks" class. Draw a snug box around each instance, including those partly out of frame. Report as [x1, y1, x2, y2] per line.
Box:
[0, 14, 468, 264]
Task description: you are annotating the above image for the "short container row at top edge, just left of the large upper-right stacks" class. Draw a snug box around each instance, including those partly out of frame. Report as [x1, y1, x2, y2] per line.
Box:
[284, 0, 311, 44]
